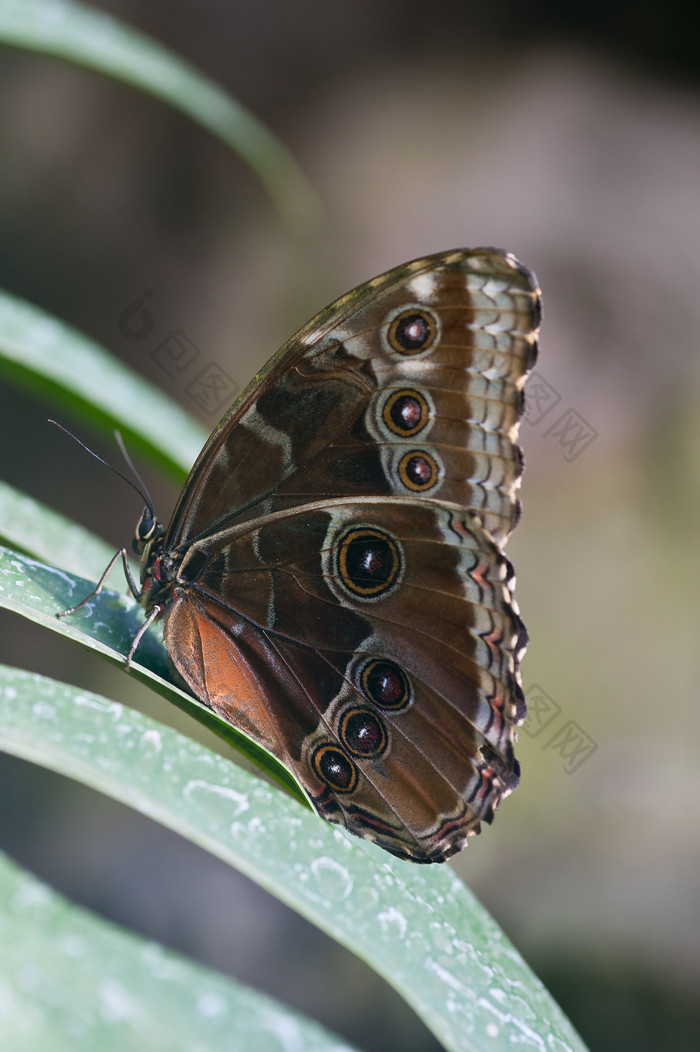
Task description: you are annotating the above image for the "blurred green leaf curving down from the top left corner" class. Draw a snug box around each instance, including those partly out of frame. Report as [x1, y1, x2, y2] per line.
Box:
[0, 0, 322, 231]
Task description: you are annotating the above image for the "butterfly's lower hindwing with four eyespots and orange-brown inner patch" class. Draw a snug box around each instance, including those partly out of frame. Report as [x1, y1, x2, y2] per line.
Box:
[165, 498, 526, 862]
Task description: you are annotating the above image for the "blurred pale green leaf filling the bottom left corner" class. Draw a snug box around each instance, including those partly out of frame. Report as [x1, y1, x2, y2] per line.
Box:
[0, 855, 349, 1052]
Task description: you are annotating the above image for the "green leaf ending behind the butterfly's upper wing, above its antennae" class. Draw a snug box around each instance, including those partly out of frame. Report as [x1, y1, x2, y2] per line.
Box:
[0, 290, 207, 483]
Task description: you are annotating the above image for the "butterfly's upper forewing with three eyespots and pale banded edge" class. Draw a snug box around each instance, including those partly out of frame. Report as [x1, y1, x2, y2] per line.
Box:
[166, 249, 540, 548]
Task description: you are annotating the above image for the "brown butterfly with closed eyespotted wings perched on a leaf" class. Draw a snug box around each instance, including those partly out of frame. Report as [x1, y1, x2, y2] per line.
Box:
[60, 248, 540, 863]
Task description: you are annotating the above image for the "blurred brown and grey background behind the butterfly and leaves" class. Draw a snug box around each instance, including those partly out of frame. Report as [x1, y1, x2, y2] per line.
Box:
[0, 0, 700, 1052]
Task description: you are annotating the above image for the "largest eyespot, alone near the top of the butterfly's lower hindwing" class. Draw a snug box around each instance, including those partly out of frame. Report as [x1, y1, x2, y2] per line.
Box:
[336, 526, 403, 599]
